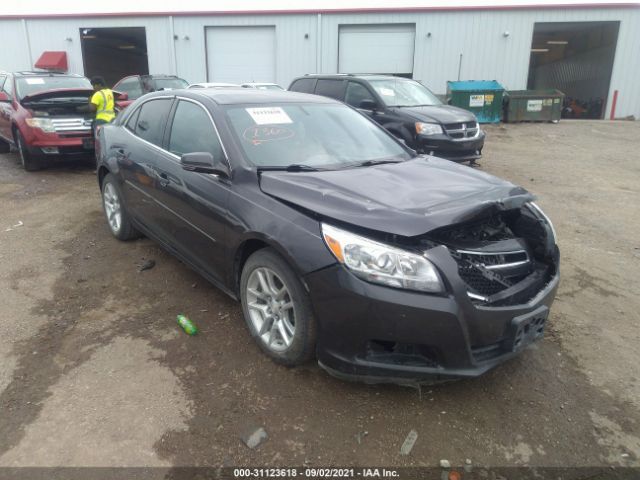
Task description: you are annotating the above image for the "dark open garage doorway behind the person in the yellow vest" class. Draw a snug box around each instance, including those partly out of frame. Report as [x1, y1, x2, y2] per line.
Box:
[80, 27, 149, 85]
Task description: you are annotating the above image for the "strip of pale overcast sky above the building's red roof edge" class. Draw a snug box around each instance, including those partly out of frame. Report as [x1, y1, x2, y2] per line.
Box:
[0, 0, 640, 15]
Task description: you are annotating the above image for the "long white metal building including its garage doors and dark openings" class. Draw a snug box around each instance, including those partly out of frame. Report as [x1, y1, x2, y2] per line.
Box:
[0, 0, 640, 118]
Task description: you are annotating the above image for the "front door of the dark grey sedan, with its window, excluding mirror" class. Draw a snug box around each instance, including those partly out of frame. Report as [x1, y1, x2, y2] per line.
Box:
[154, 98, 230, 281]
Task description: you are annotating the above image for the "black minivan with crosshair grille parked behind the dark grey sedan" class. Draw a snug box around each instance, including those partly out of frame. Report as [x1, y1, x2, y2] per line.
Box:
[289, 75, 485, 162]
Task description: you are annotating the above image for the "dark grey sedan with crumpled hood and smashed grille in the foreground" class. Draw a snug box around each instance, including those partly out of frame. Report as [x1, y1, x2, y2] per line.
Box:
[96, 89, 559, 384]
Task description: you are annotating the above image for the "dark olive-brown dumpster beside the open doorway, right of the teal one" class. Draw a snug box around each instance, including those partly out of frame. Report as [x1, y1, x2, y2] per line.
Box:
[504, 90, 564, 123]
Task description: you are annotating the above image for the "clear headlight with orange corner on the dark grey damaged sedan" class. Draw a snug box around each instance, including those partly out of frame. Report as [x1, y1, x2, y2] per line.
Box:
[322, 223, 444, 293]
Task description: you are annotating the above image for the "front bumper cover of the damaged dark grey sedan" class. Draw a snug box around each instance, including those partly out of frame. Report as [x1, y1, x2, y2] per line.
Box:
[305, 249, 559, 385]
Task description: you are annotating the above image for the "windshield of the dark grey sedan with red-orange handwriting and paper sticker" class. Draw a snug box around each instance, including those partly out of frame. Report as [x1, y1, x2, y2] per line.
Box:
[226, 103, 411, 169]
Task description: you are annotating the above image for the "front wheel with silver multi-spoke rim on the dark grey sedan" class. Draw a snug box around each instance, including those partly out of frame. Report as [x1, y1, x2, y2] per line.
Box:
[240, 248, 316, 366]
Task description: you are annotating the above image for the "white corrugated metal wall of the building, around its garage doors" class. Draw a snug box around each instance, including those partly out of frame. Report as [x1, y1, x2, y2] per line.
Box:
[0, 8, 640, 118]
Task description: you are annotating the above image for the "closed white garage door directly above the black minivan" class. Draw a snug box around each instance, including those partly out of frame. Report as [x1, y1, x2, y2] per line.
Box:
[338, 24, 416, 77]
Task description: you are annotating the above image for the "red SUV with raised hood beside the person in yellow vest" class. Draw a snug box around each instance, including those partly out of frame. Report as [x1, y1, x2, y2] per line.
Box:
[0, 72, 95, 171]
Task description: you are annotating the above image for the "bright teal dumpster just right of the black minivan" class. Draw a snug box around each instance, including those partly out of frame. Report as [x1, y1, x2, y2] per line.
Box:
[447, 80, 504, 123]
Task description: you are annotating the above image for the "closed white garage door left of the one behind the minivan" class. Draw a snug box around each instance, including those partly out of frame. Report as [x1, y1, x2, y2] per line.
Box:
[206, 27, 276, 83]
